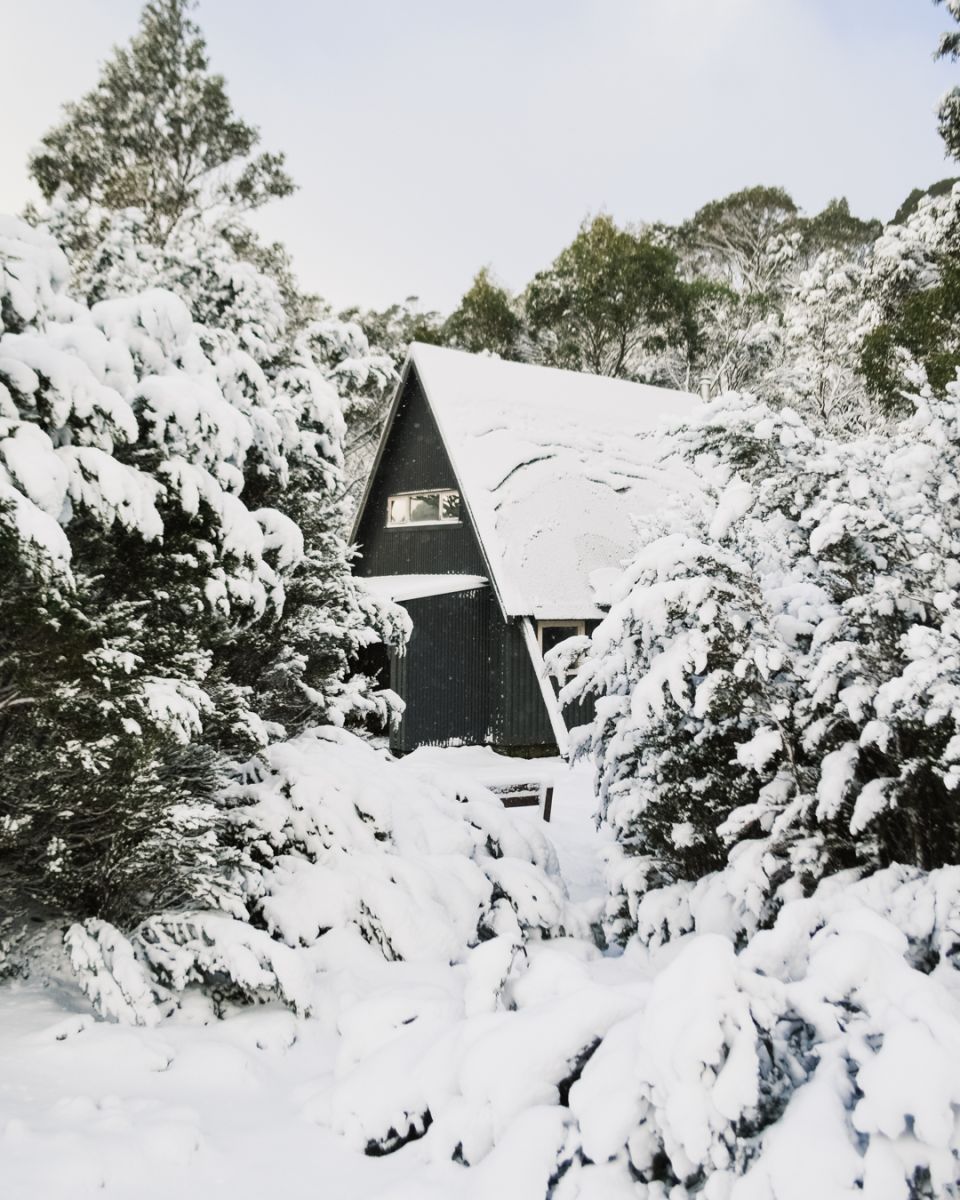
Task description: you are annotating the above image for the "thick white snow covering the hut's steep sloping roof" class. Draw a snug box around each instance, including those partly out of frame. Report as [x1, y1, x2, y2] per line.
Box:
[409, 343, 700, 618]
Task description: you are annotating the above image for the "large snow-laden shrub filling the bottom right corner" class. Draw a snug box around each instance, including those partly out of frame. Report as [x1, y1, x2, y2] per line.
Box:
[551, 868, 960, 1200]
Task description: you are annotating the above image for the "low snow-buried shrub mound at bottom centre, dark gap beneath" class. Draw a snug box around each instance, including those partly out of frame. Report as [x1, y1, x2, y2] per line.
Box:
[314, 940, 636, 1161]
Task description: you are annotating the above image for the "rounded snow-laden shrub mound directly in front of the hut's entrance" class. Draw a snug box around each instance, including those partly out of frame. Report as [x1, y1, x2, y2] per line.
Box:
[230, 728, 564, 961]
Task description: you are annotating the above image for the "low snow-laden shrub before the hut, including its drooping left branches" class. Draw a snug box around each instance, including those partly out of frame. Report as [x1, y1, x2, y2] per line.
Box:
[68, 727, 569, 1020]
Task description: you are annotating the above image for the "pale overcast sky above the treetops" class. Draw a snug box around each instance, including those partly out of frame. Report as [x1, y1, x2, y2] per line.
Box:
[0, 0, 960, 310]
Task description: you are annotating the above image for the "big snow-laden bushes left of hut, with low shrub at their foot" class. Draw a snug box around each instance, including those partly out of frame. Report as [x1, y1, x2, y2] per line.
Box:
[0, 211, 564, 1020]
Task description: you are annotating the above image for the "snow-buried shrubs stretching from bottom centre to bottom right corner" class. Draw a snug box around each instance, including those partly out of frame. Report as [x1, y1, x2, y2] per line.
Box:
[260, 868, 960, 1200]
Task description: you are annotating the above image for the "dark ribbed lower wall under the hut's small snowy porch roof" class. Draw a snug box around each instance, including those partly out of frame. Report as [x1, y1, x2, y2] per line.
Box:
[390, 587, 494, 754]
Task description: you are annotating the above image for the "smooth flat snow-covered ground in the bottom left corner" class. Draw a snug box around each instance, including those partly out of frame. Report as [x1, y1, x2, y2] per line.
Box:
[0, 985, 386, 1200]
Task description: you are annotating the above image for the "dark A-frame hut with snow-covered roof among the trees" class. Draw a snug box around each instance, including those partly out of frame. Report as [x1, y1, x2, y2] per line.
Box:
[353, 344, 696, 754]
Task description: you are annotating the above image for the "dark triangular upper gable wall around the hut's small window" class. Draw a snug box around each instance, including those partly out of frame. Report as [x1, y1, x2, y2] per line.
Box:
[355, 368, 487, 575]
